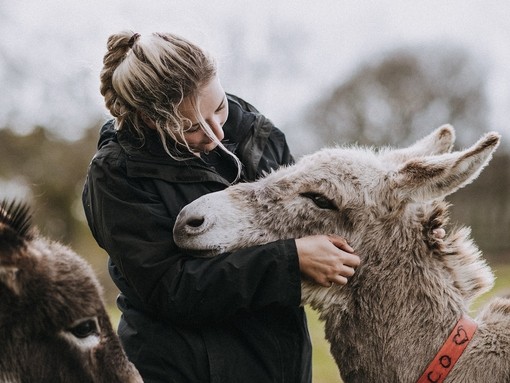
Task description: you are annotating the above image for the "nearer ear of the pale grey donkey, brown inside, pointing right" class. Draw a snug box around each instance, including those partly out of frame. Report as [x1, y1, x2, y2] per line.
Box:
[392, 132, 501, 202]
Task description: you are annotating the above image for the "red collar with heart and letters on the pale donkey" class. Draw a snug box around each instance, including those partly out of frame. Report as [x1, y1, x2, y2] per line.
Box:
[417, 314, 478, 383]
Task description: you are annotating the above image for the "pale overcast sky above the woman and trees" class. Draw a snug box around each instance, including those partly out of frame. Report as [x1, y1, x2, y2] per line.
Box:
[0, 0, 510, 148]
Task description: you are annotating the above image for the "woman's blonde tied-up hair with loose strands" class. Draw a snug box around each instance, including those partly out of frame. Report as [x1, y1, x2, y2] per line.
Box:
[100, 31, 241, 180]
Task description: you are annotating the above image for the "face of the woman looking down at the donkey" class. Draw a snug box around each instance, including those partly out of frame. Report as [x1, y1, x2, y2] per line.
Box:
[179, 76, 228, 153]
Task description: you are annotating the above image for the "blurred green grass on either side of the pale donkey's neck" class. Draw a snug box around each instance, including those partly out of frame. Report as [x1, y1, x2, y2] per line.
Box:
[307, 264, 510, 383]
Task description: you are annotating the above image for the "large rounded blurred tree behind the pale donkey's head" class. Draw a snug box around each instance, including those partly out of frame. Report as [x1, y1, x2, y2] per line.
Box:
[300, 44, 488, 150]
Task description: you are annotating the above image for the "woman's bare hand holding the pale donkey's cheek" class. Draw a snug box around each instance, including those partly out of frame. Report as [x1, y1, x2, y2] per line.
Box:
[296, 235, 360, 287]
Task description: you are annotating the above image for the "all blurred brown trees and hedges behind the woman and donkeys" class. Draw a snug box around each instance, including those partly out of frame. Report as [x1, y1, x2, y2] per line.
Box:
[0, 45, 510, 303]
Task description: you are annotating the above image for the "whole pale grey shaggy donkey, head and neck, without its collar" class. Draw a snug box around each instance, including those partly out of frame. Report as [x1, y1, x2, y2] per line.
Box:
[174, 125, 510, 383]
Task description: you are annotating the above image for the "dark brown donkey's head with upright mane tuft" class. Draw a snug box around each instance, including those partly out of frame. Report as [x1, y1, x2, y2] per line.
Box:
[0, 201, 142, 383]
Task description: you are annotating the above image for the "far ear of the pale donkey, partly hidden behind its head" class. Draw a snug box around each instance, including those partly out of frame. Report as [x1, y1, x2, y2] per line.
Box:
[383, 125, 455, 164]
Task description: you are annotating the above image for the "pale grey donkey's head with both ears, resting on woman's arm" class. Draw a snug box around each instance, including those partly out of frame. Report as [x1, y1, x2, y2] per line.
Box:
[174, 125, 499, 250]
